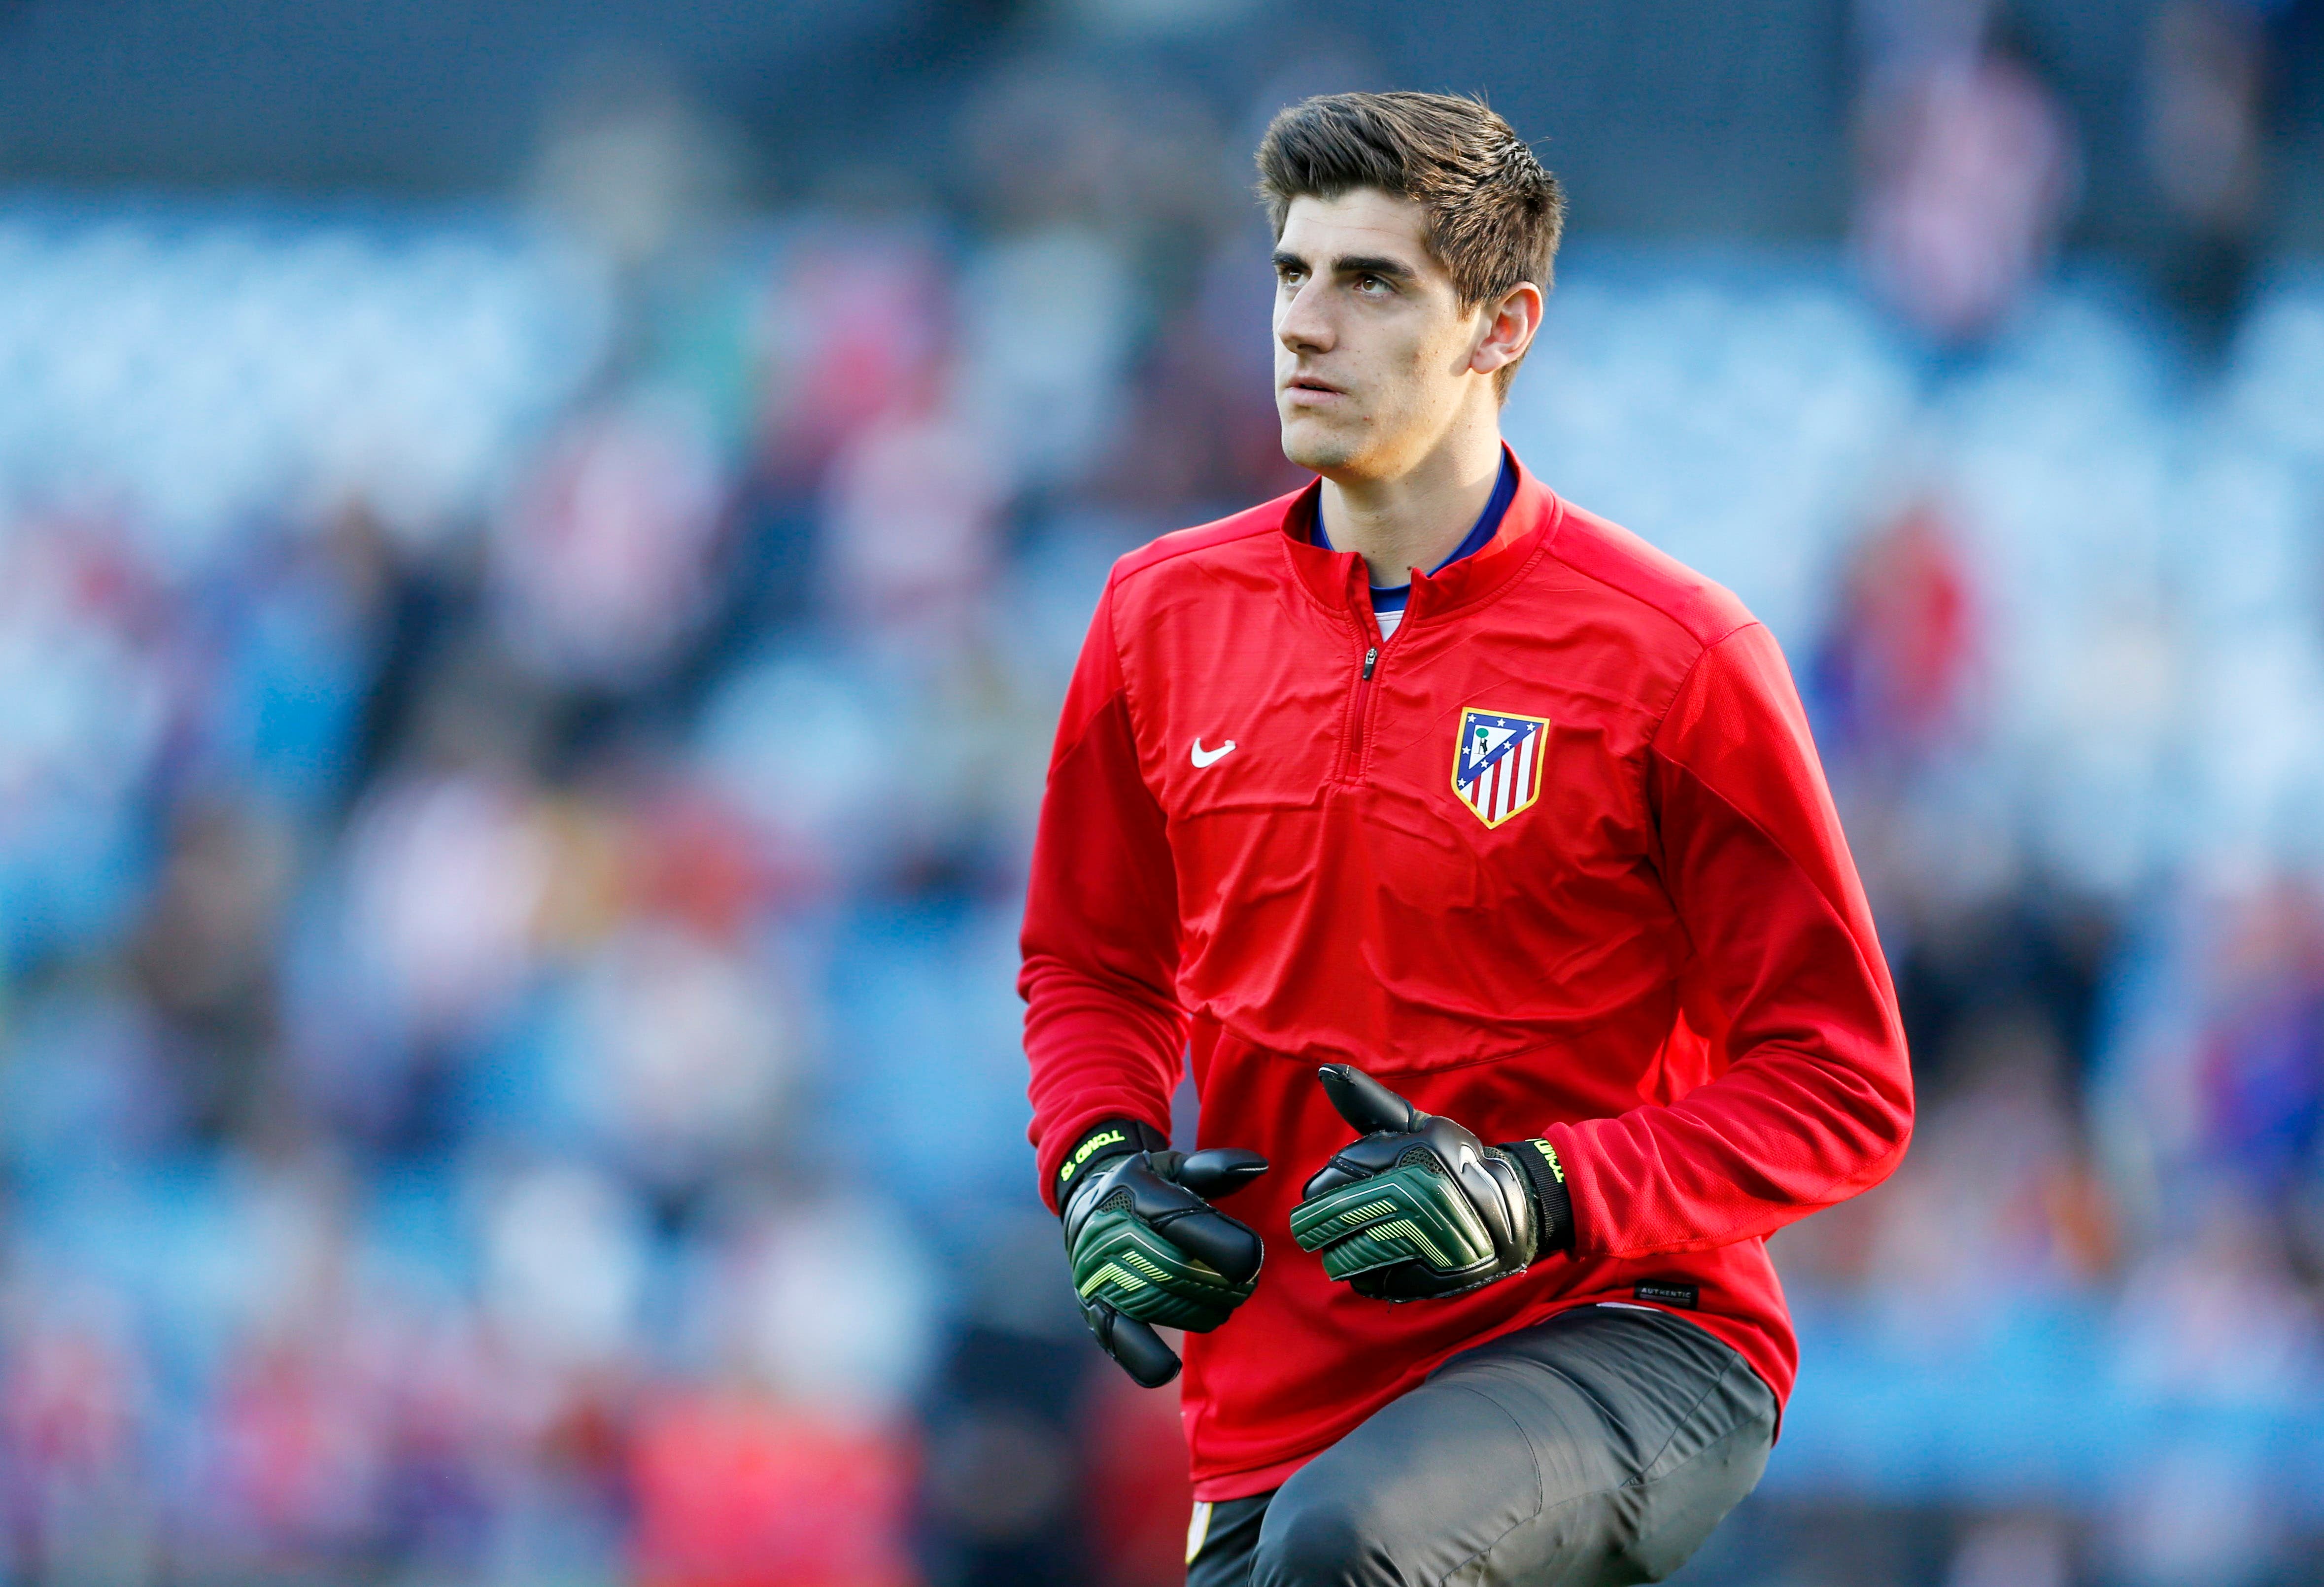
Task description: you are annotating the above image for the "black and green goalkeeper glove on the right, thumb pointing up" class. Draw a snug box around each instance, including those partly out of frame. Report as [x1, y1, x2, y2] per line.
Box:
[1292, 1064, 1573, 1301]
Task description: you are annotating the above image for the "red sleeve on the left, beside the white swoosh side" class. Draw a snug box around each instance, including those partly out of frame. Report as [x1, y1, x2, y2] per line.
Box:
[1018, 583, 1185, 1199]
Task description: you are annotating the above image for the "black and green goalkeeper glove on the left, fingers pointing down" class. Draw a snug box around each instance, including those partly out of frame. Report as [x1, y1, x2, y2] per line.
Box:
[1058, 1120, 1266, 1389]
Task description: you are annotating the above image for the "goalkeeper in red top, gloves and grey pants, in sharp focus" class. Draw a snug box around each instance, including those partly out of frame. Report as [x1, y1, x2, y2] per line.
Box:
[1020, 93, 1913, 1587]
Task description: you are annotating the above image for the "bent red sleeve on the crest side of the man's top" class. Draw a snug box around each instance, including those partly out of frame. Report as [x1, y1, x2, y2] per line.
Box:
[1548, 622, 1913, 1257]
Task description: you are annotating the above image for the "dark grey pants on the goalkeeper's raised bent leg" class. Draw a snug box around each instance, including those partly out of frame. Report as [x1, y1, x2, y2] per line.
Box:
[1185, 1306, 1776, 1587]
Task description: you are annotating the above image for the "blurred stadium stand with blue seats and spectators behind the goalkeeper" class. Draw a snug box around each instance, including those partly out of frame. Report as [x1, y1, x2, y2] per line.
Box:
[0, 0, 2324, 1587]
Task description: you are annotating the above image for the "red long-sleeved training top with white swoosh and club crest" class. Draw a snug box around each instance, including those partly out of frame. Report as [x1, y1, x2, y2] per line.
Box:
[1018, 450, 1913, 1499]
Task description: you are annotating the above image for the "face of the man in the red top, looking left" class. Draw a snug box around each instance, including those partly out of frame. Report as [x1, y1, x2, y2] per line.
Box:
[1276, 188, 1492, 479]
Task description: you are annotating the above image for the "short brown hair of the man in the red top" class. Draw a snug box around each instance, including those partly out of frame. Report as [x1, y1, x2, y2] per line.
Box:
[1257, 93, 1567, 393]
